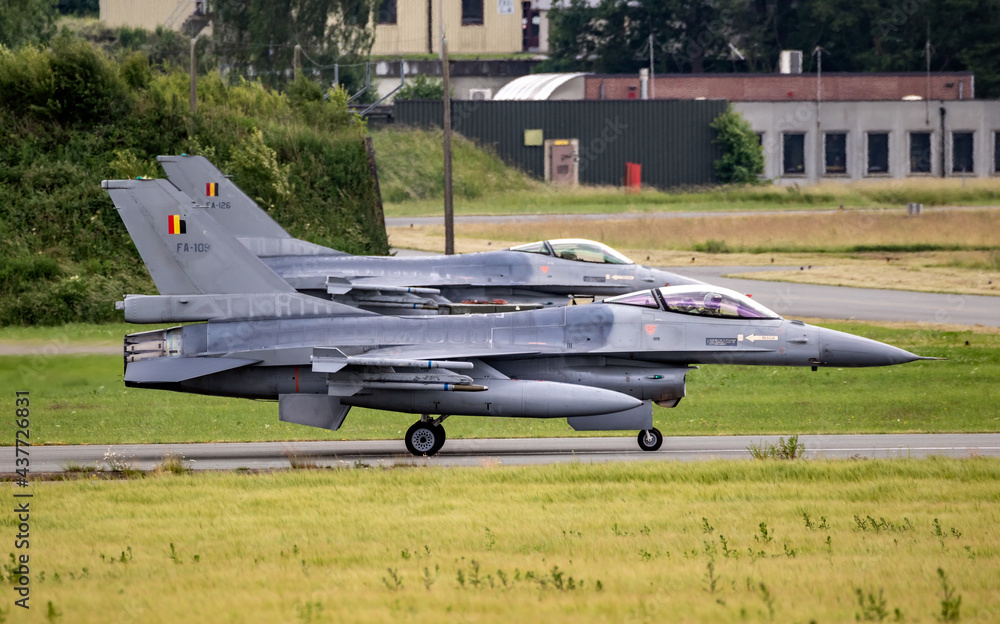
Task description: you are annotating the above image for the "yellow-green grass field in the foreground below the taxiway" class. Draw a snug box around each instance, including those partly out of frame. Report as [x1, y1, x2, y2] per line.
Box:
[0, 458, 1000, 623]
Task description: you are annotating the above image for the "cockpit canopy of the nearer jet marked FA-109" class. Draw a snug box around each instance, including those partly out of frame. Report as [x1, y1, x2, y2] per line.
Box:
[604, 286, 781, 319]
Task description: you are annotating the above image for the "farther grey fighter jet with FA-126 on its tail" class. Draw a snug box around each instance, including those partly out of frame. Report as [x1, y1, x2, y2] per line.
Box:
[157, 156, 702, 315]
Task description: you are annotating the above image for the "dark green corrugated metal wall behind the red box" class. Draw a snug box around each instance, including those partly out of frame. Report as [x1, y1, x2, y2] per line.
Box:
[393, 100, 726, 188]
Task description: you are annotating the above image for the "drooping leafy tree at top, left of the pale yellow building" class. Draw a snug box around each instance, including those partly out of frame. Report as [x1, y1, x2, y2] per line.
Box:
[213, 0, 375, 91]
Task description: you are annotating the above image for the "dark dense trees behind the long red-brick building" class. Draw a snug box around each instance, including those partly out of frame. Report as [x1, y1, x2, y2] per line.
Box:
[537, 0, 1000, 98]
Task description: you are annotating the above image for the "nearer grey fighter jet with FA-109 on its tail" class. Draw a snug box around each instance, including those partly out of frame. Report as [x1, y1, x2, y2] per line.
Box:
[103, 180, 927, 455]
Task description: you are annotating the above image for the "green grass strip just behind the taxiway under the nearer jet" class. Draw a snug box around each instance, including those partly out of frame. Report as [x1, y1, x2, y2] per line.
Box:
[0, 323, 1000, 448]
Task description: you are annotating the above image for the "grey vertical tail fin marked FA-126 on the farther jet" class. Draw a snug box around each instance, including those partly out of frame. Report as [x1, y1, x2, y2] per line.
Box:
[156, 155, 343, 256]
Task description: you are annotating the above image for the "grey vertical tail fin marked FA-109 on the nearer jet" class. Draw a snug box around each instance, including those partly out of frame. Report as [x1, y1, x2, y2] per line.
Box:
[101, 180, 295, 295]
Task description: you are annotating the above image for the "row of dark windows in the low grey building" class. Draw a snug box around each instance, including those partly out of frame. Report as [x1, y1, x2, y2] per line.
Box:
[758, 132, 988, 175]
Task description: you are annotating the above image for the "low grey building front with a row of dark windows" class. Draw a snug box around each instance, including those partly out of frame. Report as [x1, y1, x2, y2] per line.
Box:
[733, 100, 1000, 183]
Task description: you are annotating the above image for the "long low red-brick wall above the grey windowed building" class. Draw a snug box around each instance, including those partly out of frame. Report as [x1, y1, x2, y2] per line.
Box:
[586, 72, 975, 102]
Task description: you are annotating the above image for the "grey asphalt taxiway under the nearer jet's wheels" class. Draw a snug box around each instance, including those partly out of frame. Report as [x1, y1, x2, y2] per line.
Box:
[13, 433, 1000, 474]
